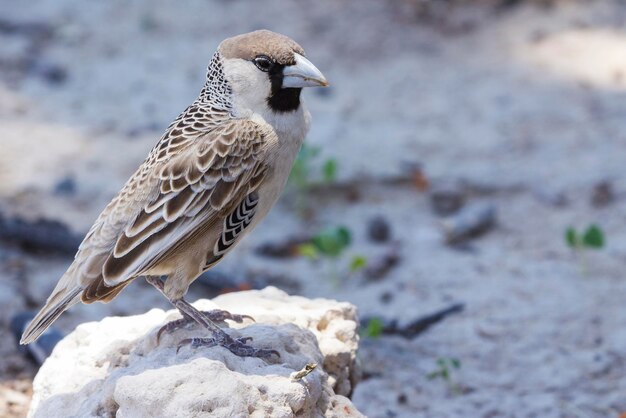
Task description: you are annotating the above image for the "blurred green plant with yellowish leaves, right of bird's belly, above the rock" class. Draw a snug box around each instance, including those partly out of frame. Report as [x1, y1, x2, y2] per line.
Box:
[298, 226, 367, 284]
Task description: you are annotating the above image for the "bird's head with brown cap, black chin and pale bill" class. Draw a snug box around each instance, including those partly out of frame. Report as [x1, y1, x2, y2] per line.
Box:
[218, 30, 328, 112]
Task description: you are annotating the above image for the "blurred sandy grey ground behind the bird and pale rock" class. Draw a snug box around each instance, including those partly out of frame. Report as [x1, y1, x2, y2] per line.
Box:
[0, 0, 626, 418]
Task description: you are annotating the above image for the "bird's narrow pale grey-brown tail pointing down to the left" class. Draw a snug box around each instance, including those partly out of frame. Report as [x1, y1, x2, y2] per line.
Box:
[20, 279, 83, 344]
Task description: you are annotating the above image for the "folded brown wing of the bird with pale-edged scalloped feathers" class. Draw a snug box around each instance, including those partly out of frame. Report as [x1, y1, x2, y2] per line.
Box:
[96, 120, 268, 286]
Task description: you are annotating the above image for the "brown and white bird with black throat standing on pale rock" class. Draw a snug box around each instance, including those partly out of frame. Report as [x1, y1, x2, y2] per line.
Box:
[20, 30, 328, 357]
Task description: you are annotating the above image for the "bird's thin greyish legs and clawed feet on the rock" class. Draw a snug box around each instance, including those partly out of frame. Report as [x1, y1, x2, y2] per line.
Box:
[146, 276, 280, 358]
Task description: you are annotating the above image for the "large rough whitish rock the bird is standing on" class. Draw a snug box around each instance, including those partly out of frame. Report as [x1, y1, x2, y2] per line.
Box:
[28, 287, 363, 418]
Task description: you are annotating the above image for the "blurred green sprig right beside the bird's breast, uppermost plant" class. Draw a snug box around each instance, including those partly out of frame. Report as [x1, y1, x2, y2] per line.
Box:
[289, 144, 338, 217]
